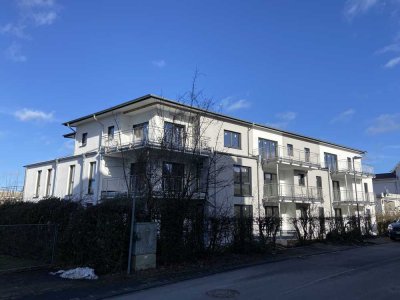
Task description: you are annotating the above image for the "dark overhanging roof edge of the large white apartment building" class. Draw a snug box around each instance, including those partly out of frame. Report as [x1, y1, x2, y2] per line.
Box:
[63, 94, 366, 154]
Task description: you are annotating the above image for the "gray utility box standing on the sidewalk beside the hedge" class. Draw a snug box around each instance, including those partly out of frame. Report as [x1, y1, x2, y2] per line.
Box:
[133, 222, 157, 271]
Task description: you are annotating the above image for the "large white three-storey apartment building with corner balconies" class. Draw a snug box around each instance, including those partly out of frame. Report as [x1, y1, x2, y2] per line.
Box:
[24, 95, 375, 230]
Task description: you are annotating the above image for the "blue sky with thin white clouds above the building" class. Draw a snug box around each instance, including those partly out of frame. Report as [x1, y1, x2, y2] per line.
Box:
[0, 0, 400, 185]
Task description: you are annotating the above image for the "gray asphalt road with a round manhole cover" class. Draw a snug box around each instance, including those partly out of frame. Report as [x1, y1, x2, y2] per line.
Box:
[108, 242, 400, 300]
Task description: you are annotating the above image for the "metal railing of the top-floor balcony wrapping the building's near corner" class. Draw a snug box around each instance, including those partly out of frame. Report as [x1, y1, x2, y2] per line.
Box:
[101, 126, 211, 155]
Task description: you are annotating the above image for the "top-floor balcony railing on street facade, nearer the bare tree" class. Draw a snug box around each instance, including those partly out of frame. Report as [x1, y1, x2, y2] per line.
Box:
[255, 146, 321, 167]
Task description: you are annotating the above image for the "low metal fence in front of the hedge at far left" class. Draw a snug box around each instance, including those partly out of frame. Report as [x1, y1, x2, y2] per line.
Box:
[0, 224, 57, 273]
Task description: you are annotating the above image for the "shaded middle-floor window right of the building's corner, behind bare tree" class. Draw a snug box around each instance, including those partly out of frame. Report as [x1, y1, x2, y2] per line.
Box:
[162, 162, 185, 192]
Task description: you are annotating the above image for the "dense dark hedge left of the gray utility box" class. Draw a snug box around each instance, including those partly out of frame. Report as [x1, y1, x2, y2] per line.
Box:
[0, 199, 131, 274]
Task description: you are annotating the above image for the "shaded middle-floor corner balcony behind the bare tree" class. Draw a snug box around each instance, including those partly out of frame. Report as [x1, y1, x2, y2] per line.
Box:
[101, 176, 205, 199]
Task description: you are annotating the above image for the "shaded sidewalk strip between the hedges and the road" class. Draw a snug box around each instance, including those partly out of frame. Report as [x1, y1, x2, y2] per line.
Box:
[0, 238, 391, 299]
